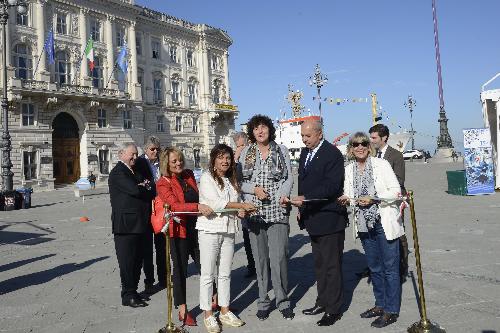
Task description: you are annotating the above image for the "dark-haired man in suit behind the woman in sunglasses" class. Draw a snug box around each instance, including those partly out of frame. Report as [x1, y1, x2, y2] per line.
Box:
[370, 124, 408, 283]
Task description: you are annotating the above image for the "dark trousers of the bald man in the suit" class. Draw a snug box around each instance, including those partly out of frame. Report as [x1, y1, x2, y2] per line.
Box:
[311, 230, 345, 314]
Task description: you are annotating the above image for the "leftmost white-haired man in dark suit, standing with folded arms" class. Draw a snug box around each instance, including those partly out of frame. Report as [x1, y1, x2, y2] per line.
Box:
[108, 143, 154, 307]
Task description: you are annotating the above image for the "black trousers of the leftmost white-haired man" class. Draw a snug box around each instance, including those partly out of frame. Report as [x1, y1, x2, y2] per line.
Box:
[114, 234, 148, 300]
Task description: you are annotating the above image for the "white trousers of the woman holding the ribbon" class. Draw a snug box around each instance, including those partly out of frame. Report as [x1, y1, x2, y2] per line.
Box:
[198, 230, 234, 311]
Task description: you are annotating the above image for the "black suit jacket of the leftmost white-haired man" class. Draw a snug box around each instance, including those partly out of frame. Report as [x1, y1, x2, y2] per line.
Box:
[108, 162, 154, 234]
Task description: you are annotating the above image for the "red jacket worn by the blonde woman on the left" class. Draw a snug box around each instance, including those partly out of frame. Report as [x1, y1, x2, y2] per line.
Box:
[156, 170, 198, 238]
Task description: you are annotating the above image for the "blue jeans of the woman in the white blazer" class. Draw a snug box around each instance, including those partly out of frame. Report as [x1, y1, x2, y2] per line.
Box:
[359, 222, 401, 314]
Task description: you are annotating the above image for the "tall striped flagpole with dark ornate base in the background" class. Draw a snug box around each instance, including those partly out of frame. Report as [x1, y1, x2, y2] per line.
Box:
[432, 0, 453, 149]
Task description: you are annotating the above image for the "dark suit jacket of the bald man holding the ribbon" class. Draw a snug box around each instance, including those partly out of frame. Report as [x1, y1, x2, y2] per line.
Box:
[298, 140, 348, 236]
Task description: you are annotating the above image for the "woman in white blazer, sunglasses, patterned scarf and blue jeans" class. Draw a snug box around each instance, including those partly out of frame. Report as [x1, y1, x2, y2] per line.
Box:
[339, 132, 404, 328]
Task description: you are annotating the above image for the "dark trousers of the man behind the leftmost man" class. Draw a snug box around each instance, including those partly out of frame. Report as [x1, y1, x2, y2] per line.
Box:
[142, 233, 167, 285]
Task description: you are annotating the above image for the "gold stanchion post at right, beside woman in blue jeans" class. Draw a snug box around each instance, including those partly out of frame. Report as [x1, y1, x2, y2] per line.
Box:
[408, 191, 446, 333]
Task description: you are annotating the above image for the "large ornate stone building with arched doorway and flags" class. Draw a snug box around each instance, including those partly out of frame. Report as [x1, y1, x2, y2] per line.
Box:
[1, 0, 238, 189]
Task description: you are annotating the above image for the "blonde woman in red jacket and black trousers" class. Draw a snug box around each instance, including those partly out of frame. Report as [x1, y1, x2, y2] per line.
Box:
[156, 147, 213, 326]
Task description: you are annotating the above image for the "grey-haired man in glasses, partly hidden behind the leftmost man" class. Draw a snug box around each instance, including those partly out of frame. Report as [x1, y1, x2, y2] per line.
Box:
[135, 136, 167, 294]
